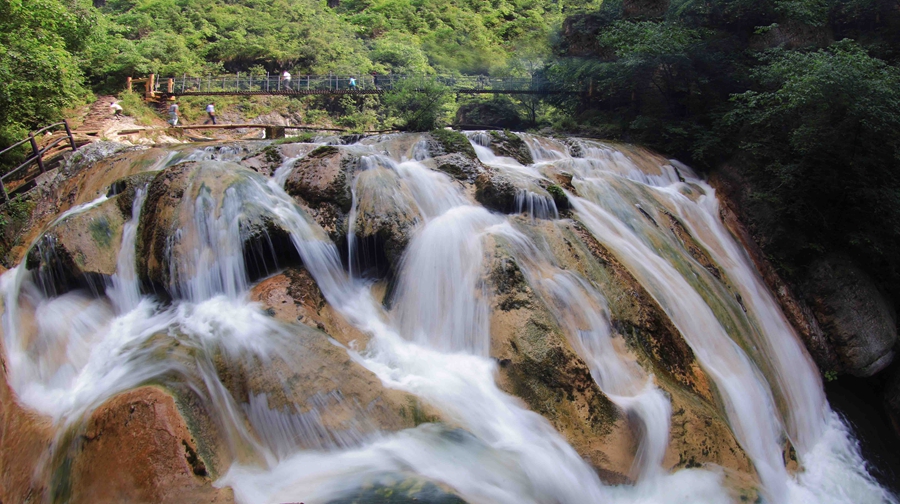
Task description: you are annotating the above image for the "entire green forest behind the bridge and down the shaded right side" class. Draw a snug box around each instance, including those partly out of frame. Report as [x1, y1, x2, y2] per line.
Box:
[0, 0, 900, 316]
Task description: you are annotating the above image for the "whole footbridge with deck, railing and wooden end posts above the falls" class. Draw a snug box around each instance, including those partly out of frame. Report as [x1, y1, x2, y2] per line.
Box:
[126, 72, 590, 99]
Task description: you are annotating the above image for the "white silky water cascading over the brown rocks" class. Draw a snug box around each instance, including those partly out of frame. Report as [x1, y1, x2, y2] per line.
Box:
[0, 133, 896, 503]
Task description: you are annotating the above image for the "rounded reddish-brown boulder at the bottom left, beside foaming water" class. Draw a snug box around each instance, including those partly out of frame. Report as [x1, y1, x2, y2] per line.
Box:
[62, 387, 234, 503]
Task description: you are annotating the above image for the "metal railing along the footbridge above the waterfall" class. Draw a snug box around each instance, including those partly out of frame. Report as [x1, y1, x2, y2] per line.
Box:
[154, 73, 561, 95]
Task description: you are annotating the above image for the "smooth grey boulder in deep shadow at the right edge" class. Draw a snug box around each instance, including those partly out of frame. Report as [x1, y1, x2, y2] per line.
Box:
[804, 256, 897, 377]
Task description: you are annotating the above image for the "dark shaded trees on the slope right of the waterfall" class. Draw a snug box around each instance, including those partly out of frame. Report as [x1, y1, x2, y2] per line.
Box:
[547, 0, 900, 300]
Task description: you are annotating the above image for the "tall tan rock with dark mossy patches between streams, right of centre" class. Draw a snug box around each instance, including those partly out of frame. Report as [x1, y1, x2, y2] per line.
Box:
[488, 238, 635, 483]
